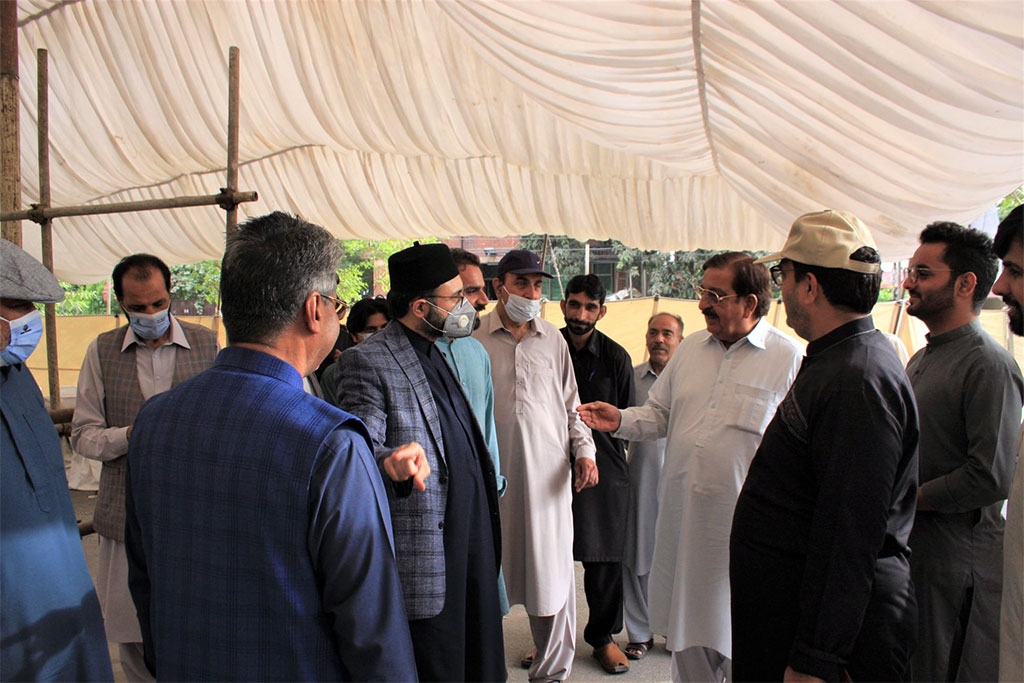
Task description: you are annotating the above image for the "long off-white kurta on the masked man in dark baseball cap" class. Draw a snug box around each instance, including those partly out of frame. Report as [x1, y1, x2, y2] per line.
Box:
[473, 312, 595, 616]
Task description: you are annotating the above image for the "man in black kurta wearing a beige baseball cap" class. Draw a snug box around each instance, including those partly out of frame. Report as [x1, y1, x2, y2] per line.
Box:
[729, 211, 918, 681]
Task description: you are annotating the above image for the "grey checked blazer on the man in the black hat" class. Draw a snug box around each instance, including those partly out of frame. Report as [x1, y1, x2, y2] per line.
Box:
[337, 321, 501, 620]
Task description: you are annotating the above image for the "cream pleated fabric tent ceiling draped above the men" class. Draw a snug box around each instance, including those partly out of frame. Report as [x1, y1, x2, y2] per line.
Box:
[17, 0, 1024, 283]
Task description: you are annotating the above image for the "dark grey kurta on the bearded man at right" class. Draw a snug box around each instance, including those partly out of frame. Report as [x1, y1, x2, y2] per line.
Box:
[907, 321, 1024, 680]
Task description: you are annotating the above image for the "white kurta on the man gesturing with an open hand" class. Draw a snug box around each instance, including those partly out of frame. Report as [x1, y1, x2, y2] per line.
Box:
[615, 318, 802, 657]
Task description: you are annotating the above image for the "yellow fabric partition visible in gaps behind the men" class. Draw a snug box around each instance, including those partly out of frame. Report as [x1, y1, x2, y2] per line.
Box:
[22, 305, 1024, 395]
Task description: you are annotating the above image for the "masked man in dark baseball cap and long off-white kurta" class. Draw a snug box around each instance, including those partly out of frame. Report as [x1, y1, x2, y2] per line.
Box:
[473, 249, 598, 680]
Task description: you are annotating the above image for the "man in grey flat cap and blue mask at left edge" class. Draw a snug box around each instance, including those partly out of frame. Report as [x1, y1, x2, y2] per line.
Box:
[0, 240, 114, 681]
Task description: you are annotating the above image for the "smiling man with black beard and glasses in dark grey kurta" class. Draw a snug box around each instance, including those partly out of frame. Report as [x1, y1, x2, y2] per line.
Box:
[903, 222, 1024, 681]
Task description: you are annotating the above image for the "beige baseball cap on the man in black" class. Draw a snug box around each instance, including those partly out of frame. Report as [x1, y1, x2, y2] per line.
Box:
[755, 209, 882, 273]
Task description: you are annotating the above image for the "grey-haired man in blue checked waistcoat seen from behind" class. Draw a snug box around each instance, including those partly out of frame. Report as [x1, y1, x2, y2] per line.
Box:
[126, 212, 416, 681]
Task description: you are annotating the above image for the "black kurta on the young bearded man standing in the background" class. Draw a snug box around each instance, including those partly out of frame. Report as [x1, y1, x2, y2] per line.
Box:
[562, 328, 636, 562]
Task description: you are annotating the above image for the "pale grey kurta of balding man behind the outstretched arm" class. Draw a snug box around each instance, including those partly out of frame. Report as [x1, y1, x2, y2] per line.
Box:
[623, 361, 665, 577]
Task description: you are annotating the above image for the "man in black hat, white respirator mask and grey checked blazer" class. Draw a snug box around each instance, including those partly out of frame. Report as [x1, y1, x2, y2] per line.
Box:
[338, 244, 507, 681]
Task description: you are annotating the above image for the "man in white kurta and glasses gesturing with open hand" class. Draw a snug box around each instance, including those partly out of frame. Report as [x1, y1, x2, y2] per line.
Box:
[580, 252, 801, 681]
